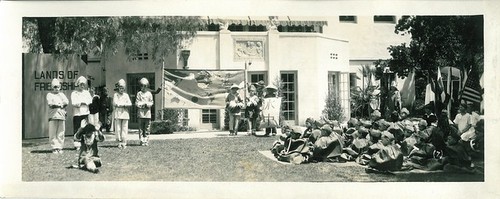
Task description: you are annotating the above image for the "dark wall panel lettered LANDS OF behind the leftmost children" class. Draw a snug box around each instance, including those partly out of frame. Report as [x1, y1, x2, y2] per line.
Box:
[22, 53, 87, 139]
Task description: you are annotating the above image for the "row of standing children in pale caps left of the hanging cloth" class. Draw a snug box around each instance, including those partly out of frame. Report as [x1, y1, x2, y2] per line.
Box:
[46, 76, 153, 153]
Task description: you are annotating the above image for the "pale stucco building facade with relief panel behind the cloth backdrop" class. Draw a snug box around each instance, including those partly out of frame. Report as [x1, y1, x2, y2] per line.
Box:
[23, 16, 409, 138]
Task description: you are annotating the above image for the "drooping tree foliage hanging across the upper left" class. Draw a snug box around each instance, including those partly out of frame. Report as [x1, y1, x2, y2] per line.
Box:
[23, 16, 203, 62]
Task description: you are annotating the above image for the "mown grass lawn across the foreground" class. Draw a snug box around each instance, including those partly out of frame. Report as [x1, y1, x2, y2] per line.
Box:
[22, 134, 484, 182]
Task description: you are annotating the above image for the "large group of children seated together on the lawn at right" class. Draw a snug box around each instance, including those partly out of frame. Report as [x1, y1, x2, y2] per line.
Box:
[271, 104, 484, 172]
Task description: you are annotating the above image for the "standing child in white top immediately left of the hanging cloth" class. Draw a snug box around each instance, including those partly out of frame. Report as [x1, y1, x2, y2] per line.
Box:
[135, 78, 153, 146]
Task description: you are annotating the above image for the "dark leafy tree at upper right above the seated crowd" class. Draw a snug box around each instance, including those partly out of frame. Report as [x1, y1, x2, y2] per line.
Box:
[385, 16, 484, 107]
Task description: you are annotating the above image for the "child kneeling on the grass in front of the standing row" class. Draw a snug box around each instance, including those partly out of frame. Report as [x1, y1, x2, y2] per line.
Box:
[74, 120, 105, 173]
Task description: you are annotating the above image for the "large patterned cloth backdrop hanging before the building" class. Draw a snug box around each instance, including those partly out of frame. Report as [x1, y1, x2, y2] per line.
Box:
[163, 69, 244, 109]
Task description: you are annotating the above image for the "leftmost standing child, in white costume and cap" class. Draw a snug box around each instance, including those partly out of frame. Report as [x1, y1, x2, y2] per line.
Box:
[47, 79, 69, 153]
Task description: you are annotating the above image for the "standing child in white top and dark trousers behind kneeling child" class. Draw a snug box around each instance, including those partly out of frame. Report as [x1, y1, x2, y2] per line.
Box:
[71, 76, 92, 150]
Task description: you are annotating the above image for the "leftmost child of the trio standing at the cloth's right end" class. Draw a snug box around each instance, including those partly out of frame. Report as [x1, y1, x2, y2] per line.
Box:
[226, 84, 243, 135]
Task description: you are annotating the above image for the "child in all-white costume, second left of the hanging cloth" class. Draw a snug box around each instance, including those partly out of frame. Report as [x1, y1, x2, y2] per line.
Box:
[113, 79, 132, 149]
